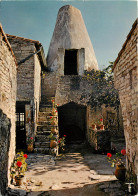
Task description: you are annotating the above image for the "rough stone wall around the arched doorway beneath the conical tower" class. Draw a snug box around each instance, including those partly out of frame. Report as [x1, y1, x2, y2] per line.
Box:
[42, 72, 124, 137]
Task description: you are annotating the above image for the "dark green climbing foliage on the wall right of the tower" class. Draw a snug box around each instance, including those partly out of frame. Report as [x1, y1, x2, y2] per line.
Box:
[84, 62, 120, 108]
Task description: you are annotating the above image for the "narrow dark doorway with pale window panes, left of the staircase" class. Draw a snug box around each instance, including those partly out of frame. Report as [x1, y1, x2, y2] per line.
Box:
[16, 103, 26, 150]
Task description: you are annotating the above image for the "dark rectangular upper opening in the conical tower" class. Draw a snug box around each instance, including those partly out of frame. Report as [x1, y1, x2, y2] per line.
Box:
[64, 50, 78, 75]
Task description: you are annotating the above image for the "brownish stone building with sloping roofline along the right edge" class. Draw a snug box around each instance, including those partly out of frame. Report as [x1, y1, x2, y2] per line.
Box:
[113, 20, 138, 183]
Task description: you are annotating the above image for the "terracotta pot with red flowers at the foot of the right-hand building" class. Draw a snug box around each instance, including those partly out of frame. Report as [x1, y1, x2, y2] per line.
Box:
[107, 149, 126, 181]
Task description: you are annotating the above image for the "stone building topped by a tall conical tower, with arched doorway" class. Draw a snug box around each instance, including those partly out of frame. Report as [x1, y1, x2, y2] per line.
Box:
[39, 5, 123, 152]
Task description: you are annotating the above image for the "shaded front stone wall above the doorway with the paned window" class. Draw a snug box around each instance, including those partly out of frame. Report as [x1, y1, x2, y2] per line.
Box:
[8, 37, 35, 101]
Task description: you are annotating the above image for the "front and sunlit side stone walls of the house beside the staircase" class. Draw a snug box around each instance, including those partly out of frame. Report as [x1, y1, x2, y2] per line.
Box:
[8, 35, 41, 140]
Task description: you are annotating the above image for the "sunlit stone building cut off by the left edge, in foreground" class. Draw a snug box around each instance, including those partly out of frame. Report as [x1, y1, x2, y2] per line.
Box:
[0, 24, 17, 195]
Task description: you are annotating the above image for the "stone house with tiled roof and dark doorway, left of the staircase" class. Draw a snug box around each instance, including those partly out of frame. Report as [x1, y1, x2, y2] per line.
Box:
[7, 34, 46, 149]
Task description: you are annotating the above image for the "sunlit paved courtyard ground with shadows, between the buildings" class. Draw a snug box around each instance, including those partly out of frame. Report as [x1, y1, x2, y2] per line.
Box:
[8, 139, 128, 196]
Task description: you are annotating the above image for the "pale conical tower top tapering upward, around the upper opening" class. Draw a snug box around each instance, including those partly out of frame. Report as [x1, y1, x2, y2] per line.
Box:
[47, 5, 98, 71]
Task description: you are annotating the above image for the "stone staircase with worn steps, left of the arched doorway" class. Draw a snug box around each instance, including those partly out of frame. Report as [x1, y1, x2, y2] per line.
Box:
[34, 103, 55, 154]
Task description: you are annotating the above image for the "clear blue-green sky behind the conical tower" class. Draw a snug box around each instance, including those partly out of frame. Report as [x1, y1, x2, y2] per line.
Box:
[0, 0, 137, 69]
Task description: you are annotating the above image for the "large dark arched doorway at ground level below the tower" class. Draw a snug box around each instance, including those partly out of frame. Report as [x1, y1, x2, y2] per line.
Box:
[58, 102, 86, 144]
